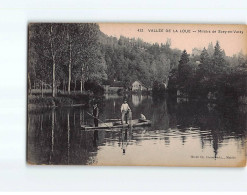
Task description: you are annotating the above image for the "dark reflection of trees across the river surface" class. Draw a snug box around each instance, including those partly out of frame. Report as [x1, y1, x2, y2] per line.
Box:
[27, 97, 247, 164]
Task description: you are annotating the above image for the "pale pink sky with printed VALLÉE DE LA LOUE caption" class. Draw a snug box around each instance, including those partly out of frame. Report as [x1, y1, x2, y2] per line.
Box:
[99, 23, 247, 56]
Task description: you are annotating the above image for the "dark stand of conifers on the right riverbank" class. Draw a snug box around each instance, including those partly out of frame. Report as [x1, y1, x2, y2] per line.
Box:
[168, 41, 247, 99]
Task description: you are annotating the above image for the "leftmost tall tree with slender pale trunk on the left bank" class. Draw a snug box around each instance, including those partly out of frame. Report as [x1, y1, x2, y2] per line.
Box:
[29, 23, 64, 97]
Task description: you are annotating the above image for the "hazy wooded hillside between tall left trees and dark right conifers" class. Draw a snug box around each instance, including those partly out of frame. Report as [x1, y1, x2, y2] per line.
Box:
[100, 33, 181, 88]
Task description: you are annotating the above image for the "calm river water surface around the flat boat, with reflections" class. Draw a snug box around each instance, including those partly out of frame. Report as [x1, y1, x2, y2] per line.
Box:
[27, 95, 246, 166]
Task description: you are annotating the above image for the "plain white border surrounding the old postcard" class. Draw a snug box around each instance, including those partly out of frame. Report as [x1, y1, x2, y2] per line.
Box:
[0, 0, 247, 191]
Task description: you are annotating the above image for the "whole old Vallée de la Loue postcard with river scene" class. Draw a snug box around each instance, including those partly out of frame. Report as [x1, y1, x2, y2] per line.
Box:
[27, 23, 247, 167]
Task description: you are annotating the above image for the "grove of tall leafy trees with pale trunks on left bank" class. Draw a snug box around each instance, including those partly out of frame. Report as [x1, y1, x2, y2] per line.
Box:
[28, 23, 107, 96]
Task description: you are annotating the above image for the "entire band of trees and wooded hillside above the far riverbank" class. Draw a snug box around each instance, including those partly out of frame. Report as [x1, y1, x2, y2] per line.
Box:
[28, 23, 247, 101]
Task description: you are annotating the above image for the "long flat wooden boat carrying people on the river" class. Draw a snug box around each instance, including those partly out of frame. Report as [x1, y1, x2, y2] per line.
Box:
[81, 119, 151, 130]
